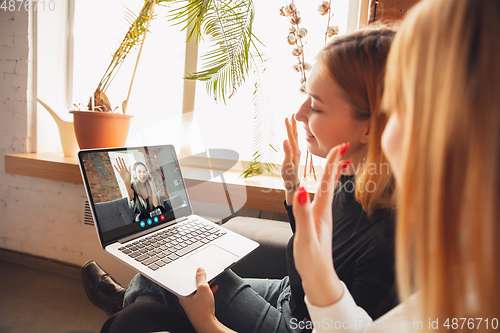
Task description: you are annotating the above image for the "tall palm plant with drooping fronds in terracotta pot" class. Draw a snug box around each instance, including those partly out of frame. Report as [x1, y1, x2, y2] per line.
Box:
[72, 0, 266, 149]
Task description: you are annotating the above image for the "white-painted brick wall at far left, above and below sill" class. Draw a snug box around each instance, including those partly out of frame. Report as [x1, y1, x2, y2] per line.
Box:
[0, 10, 137, 284]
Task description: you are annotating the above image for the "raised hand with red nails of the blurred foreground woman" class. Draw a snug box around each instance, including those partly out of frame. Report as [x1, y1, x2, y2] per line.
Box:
[293, 144, 350, 306]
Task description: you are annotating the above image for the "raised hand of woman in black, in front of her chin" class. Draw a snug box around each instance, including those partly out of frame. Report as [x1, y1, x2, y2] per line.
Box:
[281, 114, 300, 205]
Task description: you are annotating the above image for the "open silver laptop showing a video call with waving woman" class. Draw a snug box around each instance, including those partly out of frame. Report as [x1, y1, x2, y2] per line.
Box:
[78, 145, 259, 296]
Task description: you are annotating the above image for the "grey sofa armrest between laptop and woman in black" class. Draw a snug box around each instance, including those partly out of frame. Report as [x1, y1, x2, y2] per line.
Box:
[223, 216, 292, 279]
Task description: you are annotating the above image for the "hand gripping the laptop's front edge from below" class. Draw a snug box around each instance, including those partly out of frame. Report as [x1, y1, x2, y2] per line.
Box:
[179, 267, 232, 333]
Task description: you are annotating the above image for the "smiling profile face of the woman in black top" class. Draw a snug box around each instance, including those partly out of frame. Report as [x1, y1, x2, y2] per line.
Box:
[295, 65, 369, 159]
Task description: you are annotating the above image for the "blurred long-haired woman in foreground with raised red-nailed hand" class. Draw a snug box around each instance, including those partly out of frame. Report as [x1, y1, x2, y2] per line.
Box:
[293, 0, 500, 332]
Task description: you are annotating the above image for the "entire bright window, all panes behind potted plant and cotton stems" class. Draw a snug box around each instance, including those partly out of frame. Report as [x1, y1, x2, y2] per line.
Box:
[38, 0, 359, 163]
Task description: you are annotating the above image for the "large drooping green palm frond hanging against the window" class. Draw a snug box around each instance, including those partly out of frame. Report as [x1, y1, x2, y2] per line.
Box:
[171, 0, 260, 102]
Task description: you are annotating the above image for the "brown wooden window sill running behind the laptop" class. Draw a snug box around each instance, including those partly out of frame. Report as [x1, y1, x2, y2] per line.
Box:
[5, 153, 292, 214]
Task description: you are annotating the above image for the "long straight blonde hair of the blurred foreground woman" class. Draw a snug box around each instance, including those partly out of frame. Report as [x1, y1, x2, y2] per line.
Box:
[383, 0, 500, 331]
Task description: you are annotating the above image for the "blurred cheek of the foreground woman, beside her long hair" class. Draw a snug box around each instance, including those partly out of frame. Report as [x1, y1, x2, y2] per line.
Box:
[382, 112, 403, 184]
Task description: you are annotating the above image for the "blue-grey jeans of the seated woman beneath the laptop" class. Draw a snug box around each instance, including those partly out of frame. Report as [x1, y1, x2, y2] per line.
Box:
[124, 270, 297, 333]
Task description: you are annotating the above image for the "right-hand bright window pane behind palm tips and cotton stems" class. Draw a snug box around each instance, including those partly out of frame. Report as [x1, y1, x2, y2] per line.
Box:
[195, 0, 357, 163]
